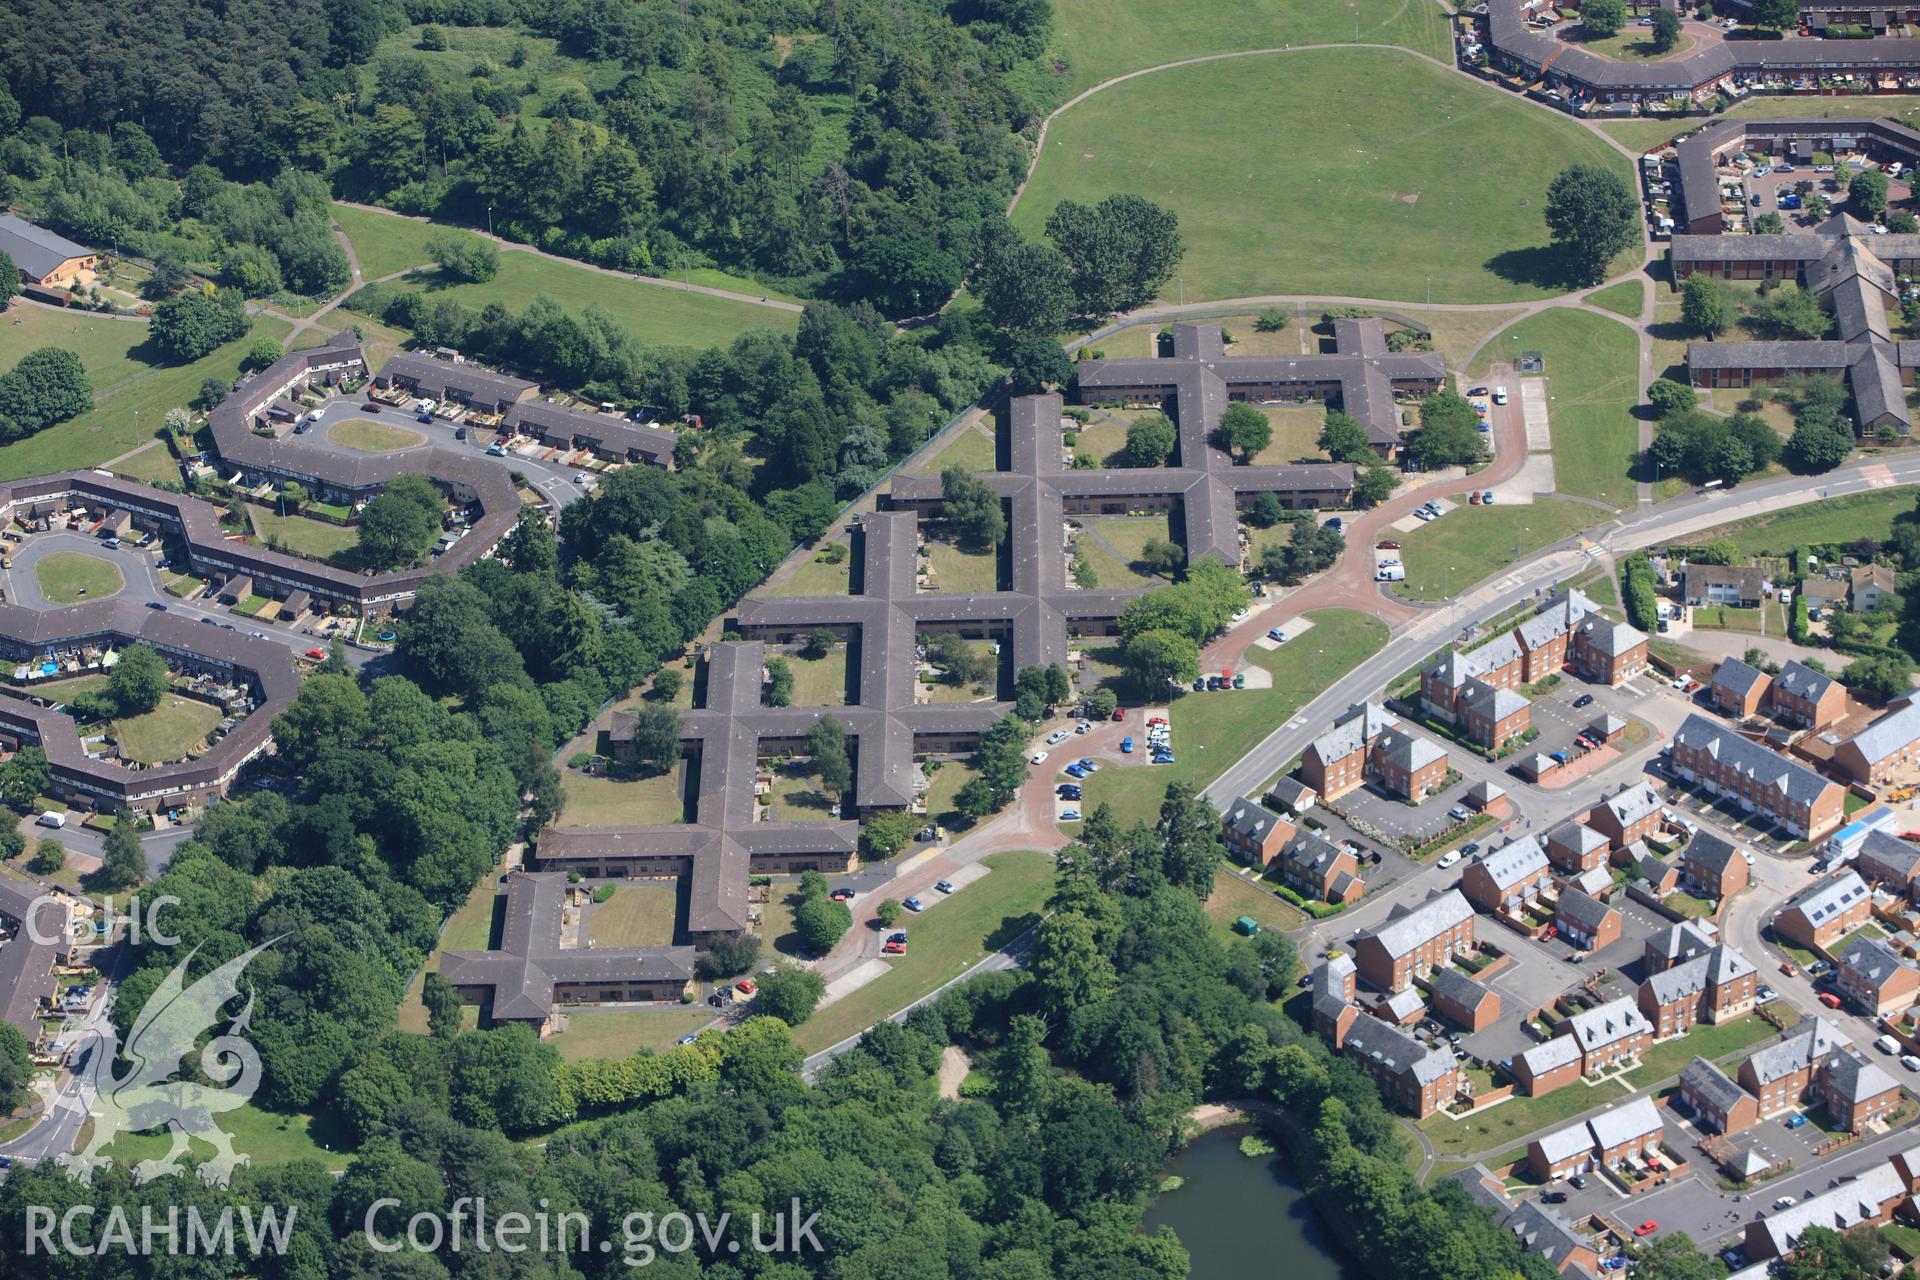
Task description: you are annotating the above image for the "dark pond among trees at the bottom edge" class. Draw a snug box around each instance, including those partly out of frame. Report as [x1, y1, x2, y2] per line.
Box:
[1142, 1125, 1359, 1280]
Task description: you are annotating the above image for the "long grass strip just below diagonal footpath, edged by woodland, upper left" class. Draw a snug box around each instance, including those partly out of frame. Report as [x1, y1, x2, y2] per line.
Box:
[374, 251, 801, 349]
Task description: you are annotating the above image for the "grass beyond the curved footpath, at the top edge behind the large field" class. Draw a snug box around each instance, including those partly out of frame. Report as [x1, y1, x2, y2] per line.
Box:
[1054, 0, 1450, 96]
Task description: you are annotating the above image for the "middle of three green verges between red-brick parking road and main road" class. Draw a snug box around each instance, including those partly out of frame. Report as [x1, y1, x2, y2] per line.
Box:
[1081, 608, 1386, 827]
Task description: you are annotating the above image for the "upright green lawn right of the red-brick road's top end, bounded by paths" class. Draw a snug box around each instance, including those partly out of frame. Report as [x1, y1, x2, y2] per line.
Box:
[1473, 307, 1640, 506]
